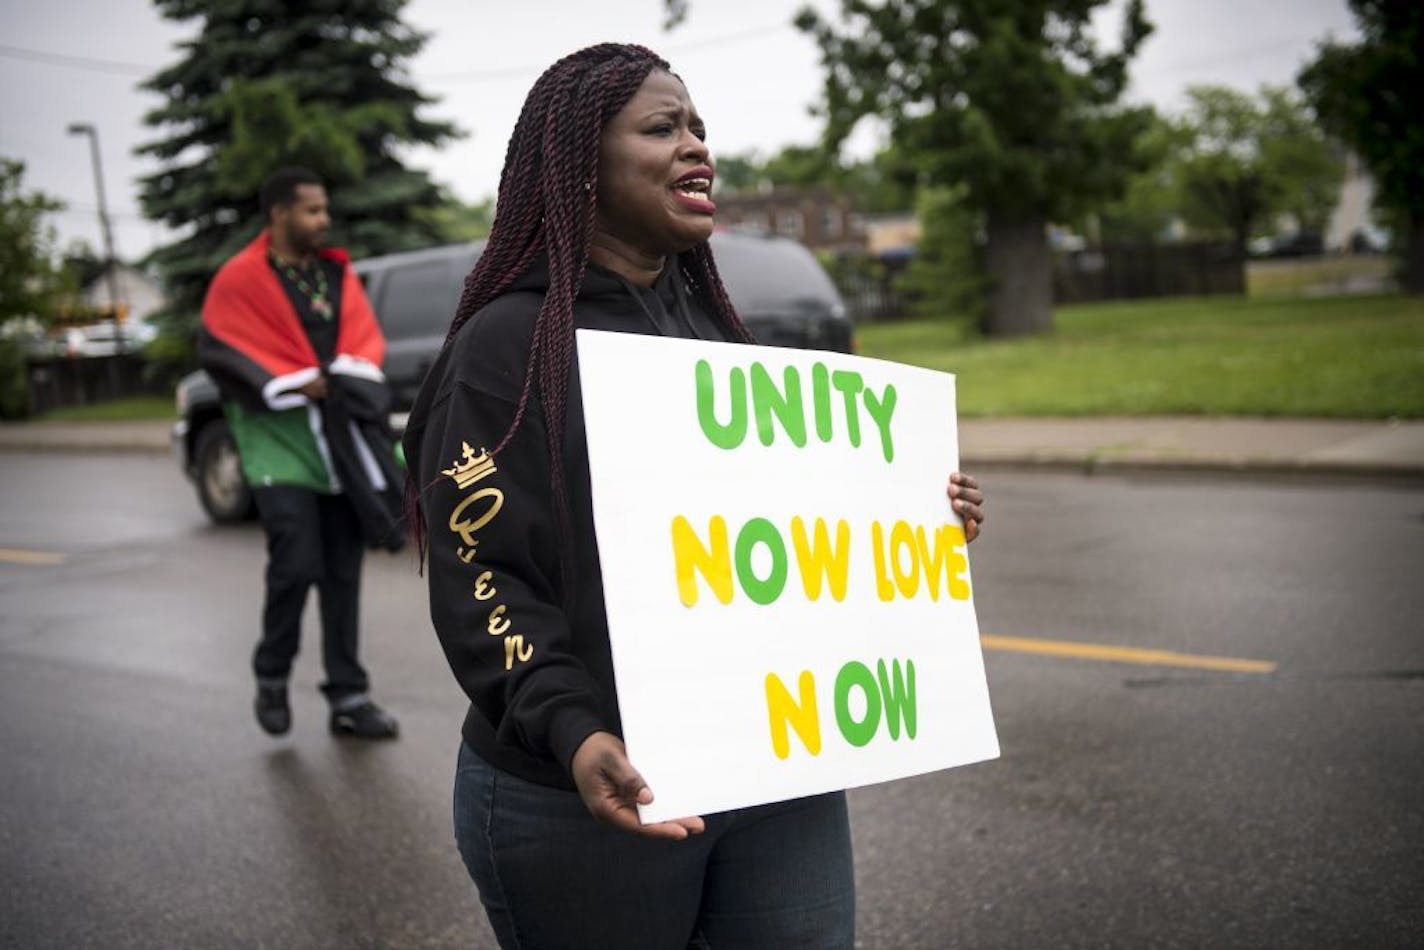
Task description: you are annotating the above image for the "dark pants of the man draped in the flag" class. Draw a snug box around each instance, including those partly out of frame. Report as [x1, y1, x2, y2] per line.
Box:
[252, 486, 369, 702]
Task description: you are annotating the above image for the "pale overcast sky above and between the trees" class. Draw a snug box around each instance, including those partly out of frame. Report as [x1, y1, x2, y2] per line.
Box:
[0, 0, 1356, 259]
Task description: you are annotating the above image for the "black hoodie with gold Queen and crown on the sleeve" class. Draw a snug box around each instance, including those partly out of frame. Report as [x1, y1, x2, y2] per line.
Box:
[404, 258, 726, 789]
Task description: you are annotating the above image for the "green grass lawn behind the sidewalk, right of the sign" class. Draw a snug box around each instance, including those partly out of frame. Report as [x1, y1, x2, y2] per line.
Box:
[857, 296, 1424, 419]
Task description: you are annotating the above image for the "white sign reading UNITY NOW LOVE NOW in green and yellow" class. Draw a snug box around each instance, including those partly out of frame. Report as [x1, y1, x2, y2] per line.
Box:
[578, 330, 998, 822]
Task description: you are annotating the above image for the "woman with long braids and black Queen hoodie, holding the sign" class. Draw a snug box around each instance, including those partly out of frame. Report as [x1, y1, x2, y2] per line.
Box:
[404, 44, 983, 949]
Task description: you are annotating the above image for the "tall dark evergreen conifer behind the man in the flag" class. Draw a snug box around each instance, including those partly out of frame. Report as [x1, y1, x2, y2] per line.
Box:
[138, 0, 457, 348]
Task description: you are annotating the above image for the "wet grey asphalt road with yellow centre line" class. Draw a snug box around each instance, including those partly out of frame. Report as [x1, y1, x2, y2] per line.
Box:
[0, 453, 1424, 949]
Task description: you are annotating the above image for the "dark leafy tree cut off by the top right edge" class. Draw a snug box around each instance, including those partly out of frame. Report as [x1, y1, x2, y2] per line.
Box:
[1300, 0, 1424, 293]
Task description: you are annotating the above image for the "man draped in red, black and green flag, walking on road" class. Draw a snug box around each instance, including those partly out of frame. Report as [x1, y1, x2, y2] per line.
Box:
[198, 168, 404, 739]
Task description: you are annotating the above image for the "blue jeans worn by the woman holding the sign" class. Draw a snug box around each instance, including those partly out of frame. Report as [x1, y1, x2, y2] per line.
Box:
[454, 742, 856, 950]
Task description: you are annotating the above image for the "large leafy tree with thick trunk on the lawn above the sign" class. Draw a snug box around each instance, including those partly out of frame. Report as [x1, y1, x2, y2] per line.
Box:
[796, 0, 1151, 335]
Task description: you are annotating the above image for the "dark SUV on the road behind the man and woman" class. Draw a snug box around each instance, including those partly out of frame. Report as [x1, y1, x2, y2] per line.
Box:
[172, 231, 854, 521]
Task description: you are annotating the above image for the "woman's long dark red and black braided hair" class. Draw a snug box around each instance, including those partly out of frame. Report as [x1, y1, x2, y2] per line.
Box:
[410, 43, 753, 581]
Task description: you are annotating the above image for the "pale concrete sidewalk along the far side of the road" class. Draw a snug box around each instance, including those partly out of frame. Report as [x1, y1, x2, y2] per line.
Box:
[8, 416, 1424, 479]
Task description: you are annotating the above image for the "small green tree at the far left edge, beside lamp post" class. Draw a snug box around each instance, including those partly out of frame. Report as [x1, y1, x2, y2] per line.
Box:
[0, 155, 73, 323]
